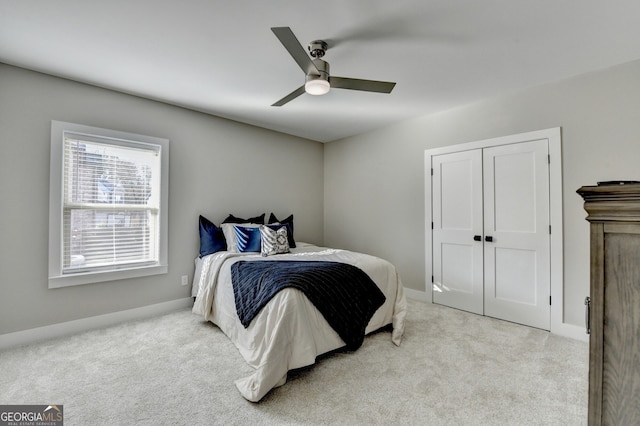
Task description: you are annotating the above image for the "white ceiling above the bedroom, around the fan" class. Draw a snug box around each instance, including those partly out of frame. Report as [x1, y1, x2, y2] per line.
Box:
[0, 0, 640, 142]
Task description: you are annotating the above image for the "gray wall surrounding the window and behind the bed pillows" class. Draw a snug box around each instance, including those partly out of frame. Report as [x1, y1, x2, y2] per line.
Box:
[0, 64, 324, 334]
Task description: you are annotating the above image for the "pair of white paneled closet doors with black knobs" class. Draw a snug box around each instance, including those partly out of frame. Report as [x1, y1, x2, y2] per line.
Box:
[432, 139, 551, 330]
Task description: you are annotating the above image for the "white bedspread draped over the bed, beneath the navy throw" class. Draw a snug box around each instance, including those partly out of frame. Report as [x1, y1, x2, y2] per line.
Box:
[192, 243, 407, 402]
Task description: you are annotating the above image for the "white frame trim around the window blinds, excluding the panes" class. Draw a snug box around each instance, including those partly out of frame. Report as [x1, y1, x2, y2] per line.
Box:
[49, 120, 169, 288]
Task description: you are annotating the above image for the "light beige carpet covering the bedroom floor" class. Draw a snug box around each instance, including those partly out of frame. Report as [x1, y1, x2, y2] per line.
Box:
[0, 300, 588, 426]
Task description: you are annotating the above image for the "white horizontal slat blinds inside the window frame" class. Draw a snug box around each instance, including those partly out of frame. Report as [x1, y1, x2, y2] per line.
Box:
[62, 133, 161, 274]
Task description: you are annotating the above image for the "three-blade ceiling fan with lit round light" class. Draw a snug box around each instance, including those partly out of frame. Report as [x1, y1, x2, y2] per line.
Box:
[271, 27, 396, 106]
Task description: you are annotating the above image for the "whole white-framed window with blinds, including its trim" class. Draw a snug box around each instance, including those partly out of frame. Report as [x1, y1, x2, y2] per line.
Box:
[49, 121, 169, 288]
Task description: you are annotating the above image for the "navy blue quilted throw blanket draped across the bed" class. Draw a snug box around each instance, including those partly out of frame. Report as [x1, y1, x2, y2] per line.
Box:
[231, 260, 385, 350]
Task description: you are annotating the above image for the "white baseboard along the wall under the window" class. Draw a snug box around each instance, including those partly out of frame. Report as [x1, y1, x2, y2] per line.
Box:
[0, 297, 193, 350]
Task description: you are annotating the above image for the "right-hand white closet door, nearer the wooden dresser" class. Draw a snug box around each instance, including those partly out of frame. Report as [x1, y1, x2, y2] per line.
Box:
[483, 139, 551, 330]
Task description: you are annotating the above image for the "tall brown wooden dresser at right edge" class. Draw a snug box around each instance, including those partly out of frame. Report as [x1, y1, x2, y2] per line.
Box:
[578, 183, 640, 425]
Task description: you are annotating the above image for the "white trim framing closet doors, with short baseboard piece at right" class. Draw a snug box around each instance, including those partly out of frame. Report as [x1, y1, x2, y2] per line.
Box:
[424, 127, 568, 338]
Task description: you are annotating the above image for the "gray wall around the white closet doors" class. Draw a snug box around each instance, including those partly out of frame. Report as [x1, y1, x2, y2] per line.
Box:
[324, 61, 640, 326]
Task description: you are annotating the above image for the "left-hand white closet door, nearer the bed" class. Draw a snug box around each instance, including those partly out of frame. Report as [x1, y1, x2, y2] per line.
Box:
[432, 149, 483, 315]
